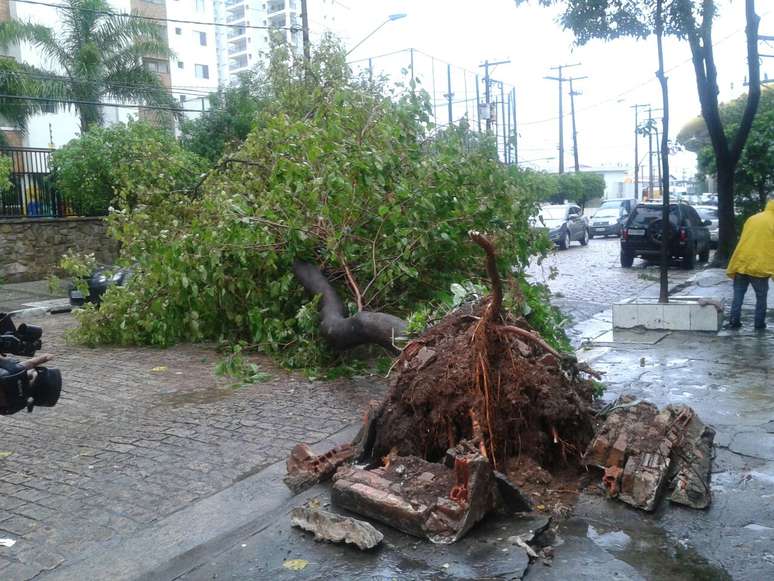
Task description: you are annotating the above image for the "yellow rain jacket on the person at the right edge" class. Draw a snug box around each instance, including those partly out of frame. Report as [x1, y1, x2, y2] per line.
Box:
[726, 200, 774, 278]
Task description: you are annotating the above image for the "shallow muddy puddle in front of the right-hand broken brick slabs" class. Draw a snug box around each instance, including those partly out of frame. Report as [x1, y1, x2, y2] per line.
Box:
[560, 519, 731, 581]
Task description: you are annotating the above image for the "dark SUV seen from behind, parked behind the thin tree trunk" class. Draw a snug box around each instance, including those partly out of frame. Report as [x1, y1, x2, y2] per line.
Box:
[621, 203, 710, 268]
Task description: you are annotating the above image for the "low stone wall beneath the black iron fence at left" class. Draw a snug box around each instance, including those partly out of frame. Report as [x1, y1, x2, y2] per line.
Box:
[0, 218, 118, 282]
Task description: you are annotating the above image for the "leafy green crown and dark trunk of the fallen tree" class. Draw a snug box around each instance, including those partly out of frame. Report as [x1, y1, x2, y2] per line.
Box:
[66, 41, 561, 368]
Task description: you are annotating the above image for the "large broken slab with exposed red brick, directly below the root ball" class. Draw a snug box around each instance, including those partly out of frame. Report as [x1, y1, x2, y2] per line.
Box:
[331, 444, 498, 544]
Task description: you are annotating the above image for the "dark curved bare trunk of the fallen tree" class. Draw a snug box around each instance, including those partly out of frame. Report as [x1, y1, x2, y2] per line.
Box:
[293, 261, 406, 354]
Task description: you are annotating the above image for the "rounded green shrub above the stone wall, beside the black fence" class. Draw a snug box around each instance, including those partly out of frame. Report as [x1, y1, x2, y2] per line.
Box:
[51, 121, 206, 215]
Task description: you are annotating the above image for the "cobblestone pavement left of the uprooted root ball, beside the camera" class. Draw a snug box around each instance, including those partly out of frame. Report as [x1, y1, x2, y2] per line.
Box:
[0, 315, 382, 580]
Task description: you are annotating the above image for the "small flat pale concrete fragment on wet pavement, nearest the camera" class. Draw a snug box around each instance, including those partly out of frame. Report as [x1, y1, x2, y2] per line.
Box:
[290, 506, 384, 551]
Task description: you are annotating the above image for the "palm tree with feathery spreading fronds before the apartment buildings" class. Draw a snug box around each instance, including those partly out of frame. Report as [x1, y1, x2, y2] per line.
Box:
[0, 0, 177, 132]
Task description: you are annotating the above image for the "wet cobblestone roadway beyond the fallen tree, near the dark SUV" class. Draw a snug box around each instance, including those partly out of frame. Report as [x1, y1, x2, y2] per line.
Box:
[529, 238, 694, 323]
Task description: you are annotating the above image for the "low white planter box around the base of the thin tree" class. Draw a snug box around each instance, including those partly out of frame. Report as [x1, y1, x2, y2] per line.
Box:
[613, 297, 723, 332]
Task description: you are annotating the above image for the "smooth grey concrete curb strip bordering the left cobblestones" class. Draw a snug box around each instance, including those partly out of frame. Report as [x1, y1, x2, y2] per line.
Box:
[44, 423, 360, 581]
